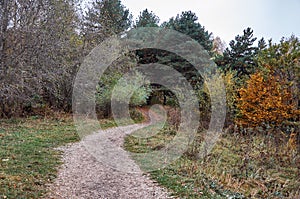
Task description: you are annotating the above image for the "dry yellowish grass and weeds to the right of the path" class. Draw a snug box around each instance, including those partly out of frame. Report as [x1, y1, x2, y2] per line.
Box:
[125, 128, 300, 199]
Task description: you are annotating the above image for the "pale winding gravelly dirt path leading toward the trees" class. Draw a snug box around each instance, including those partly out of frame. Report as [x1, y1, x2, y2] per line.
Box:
[46, 109, 172, 199]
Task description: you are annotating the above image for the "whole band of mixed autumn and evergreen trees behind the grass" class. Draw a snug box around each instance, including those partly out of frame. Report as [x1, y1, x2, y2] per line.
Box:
[0, 0, 300, 143]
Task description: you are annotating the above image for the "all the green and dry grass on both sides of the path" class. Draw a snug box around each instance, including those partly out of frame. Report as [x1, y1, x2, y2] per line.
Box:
[0, 109, 300, 199]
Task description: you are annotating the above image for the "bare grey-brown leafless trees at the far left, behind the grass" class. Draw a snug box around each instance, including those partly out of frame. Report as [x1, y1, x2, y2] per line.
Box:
[0, 0, 78, 116]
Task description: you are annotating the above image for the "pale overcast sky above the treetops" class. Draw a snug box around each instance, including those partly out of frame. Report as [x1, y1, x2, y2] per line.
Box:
[122, 0, 300, 44]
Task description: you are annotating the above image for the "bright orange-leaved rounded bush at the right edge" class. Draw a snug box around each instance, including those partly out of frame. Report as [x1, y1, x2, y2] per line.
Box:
[237, 72, 299, 127]
